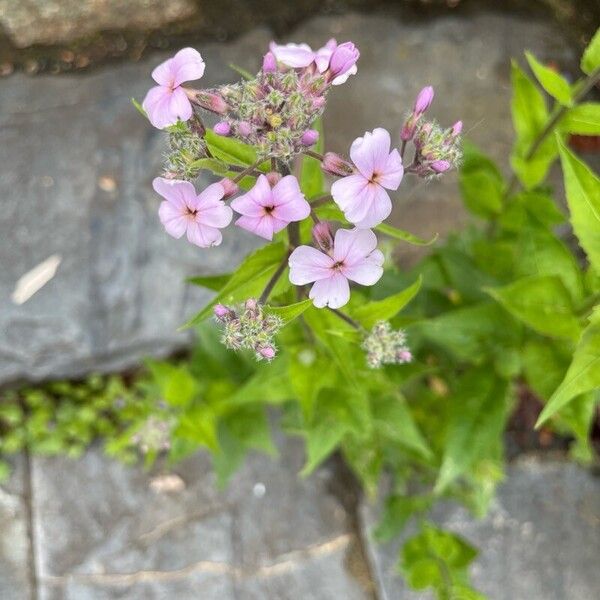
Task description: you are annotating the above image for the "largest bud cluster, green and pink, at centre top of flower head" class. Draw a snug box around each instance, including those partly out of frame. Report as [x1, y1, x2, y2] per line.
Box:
[207, 66, 327, 161]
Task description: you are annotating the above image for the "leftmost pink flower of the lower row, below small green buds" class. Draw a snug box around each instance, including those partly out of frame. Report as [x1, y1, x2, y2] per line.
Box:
[152, 177, 233, 248]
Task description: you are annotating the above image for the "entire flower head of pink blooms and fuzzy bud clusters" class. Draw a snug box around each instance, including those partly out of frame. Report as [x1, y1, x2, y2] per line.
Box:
[143, 39, 462, 366]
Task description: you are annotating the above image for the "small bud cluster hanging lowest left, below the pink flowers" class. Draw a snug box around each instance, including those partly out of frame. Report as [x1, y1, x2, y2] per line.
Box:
[214, 298, 283, 361]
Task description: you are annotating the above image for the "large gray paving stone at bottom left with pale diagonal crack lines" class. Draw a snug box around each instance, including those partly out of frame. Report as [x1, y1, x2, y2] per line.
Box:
[32, 440, 372, 600]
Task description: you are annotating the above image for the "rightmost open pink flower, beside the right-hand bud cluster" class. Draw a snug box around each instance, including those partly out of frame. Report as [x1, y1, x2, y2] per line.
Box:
[331, 127, 404, 229]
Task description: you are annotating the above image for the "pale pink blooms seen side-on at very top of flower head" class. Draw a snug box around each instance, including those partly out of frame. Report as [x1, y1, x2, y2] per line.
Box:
[270, 38, 360, 85]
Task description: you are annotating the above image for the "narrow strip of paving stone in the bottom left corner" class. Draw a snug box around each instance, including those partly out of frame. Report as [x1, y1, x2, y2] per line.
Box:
[0, 455, 32, 600]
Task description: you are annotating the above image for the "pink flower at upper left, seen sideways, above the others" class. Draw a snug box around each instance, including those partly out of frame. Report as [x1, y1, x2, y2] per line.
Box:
[142, 48, 204, 129]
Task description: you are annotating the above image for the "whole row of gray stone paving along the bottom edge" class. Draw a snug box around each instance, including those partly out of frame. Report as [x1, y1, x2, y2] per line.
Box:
[0, 450, 600, 600]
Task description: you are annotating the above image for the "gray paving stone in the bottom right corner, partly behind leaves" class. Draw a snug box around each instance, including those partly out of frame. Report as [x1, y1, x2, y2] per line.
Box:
[361, 457, 600, 600]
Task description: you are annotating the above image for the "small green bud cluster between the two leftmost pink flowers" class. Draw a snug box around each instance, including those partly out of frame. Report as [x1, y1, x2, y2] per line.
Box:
[164, 118, 207, 181]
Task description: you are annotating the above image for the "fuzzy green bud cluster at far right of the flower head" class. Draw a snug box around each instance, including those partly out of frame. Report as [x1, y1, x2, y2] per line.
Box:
[409, 121, 462, 178]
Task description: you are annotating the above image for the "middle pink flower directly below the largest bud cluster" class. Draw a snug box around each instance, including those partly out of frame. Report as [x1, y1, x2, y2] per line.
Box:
[231, 175, 310, 240]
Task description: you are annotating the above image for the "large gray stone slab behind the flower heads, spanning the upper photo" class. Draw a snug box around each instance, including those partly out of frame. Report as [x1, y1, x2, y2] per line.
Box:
[0, 14, 571, 383]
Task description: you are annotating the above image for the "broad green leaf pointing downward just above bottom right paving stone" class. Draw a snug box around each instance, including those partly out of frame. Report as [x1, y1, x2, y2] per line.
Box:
[434, 368, 508, 494]
